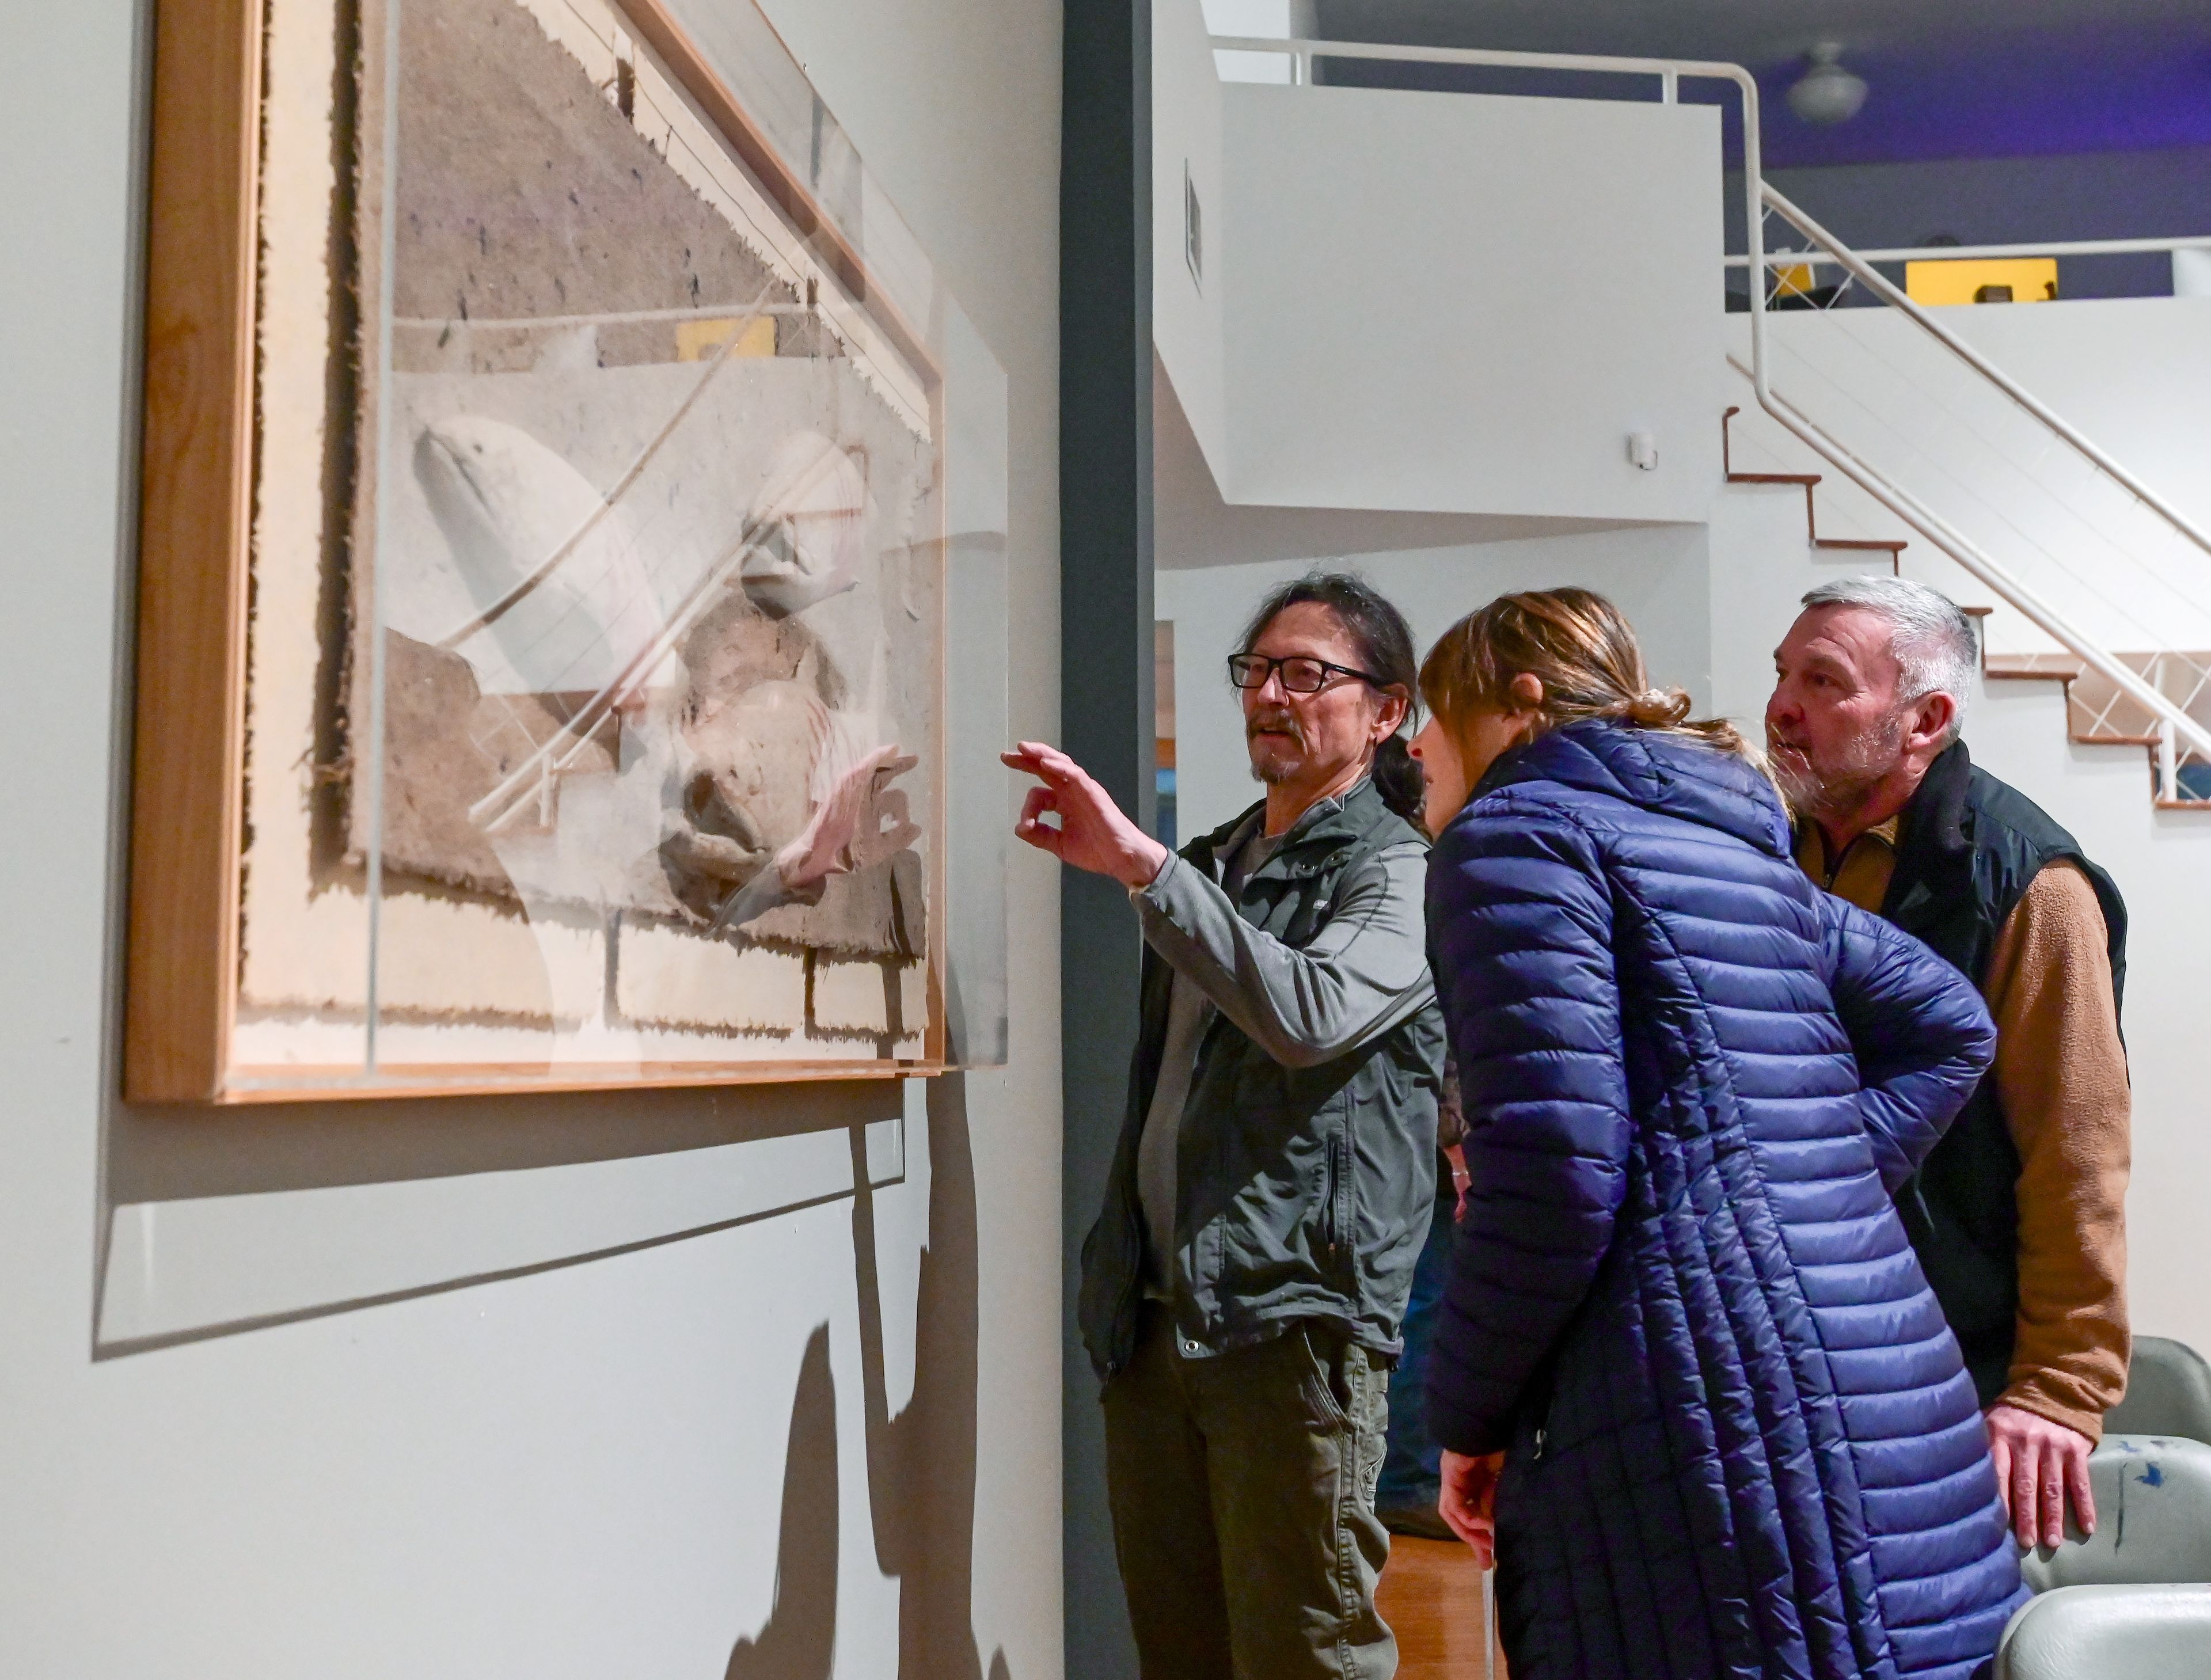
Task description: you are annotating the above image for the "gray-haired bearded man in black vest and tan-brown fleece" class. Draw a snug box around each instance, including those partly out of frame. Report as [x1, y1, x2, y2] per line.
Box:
[1766, 577, 2132, 1545]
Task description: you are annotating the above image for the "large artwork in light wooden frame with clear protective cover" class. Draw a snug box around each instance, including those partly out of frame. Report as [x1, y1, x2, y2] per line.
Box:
[124, 0, 1006, 1101]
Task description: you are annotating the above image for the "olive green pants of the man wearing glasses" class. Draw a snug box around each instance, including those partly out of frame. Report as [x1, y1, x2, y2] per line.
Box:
[1103, 1302, 1397, 1680]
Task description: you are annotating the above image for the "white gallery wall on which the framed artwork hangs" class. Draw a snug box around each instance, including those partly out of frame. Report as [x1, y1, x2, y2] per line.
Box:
[0, 0, 1061, 1680]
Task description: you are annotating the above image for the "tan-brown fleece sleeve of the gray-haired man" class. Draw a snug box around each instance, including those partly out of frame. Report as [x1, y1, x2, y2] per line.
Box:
[1985, 862, 2134, 1441]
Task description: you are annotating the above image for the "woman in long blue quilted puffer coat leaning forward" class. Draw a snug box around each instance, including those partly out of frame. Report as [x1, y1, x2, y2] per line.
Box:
[1413, 590, 2023, 1680]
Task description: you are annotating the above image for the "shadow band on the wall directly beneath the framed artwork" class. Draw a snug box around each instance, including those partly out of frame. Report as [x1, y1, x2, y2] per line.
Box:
[93, 1079, 902, 1357]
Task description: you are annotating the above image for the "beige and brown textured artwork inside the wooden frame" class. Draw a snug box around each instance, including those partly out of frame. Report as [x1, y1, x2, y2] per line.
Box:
[234, 0, 944, 1074]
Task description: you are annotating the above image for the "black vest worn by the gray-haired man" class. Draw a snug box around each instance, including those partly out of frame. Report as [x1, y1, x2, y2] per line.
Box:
[1882, 740, 2127, 1406]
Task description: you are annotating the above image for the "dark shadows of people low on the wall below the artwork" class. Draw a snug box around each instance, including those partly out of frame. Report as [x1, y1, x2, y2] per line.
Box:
[725, 1074, 1010, 1680]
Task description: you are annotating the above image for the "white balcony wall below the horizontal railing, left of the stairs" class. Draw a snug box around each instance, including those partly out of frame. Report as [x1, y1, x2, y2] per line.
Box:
[1152, 0, 1724, 522]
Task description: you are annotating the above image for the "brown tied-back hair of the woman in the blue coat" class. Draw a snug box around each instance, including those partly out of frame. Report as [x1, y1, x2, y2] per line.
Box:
[1419, 588, 1760, 763]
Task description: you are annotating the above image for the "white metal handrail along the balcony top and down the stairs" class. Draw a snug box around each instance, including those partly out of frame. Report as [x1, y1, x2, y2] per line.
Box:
[1211, 35, 2211, 773]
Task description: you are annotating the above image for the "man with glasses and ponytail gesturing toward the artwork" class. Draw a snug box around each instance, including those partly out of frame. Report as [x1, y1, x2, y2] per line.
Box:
[1006, 572, 1444, 1680]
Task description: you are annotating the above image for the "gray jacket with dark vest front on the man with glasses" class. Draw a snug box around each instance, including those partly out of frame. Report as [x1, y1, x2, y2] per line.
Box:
[1079, 782, 1444, 1377]
